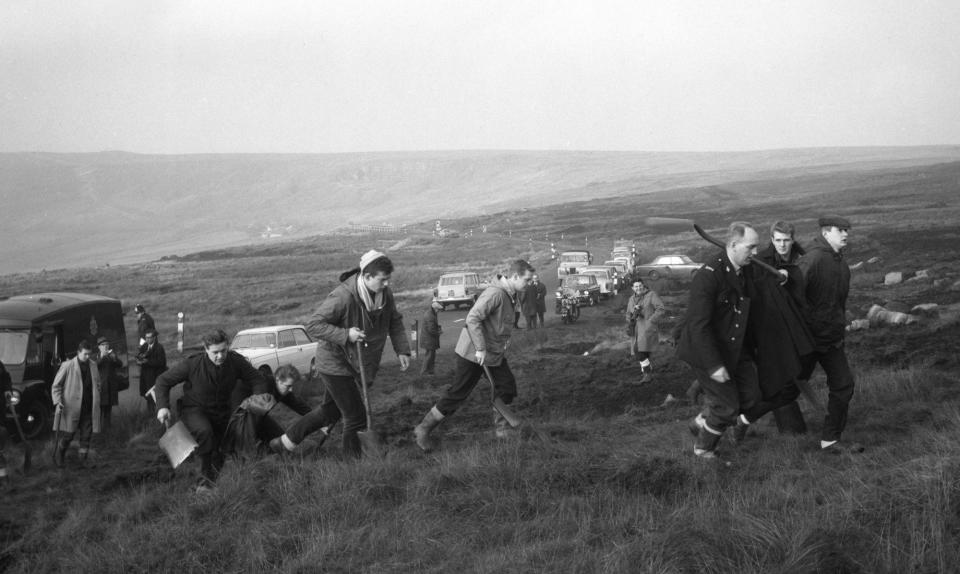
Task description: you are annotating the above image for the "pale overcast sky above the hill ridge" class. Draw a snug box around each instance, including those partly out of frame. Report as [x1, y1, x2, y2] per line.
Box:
[0, 0, 960, 153]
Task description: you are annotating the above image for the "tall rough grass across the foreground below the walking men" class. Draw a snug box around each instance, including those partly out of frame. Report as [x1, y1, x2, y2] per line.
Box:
[6, 362, 960, 573]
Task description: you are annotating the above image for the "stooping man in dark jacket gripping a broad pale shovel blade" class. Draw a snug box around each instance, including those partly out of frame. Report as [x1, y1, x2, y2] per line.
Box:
[156, 329, 270, 492]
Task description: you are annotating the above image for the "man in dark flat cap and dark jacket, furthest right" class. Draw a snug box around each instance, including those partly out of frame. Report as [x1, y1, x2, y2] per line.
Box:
[799, 215, 863, 454]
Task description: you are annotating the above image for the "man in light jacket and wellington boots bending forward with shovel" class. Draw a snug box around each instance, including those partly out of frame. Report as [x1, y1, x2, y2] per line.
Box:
[413, 259, 534, 452]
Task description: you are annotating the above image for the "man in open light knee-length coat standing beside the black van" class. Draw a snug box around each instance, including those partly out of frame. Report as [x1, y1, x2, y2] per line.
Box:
[50, 340, 100, 468]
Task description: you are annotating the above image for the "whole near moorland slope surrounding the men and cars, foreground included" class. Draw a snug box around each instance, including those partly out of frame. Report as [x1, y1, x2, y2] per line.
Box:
[0, 159, 960, 573]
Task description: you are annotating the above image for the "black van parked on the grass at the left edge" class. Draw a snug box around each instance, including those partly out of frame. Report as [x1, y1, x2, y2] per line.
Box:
[0, 293, 128, 438]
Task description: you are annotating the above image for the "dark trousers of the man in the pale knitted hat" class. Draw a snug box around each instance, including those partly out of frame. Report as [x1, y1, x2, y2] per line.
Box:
[286, 373, 369, 457]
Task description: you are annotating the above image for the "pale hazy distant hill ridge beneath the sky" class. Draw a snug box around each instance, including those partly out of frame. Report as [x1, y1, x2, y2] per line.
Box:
[0, 146, 960, 273]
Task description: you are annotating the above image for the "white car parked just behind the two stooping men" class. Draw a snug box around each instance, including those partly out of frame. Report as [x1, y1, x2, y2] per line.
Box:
[230, 325, 317, 376]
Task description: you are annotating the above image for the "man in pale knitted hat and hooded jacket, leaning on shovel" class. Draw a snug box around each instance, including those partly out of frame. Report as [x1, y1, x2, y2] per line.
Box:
[270, 250, 410, 458]
